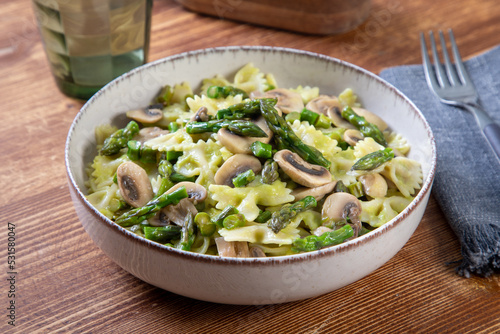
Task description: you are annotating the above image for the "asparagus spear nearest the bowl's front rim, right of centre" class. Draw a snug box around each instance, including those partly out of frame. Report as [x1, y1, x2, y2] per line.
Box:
[292, 225, 353, 253]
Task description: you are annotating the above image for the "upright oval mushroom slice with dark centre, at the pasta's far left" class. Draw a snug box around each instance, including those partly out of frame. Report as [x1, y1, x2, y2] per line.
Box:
[116, 161, 154, 208]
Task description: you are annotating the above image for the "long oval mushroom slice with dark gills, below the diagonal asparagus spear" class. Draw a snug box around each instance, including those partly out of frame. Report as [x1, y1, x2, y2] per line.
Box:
[273, 150, 332, 188]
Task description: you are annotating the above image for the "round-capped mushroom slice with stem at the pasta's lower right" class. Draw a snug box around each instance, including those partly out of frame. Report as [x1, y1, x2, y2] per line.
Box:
[321, 192, 361, 238]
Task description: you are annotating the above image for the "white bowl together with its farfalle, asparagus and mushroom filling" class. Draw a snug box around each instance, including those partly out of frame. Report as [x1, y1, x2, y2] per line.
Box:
[65, 46, 436, 304]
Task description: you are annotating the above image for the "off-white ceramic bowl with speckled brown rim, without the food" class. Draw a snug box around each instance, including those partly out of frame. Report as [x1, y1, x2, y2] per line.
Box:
[65, 47, 436, 304]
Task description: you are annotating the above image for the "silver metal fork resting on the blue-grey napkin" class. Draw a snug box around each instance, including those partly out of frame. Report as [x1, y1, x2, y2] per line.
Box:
[420, 29, 500, 160]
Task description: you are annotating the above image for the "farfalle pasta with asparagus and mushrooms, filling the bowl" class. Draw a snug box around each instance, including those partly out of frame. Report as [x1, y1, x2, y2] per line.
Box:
[87, 63, 422, 257]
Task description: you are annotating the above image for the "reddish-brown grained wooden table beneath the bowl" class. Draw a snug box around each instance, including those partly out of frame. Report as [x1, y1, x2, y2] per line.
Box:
[0, 0, 500, 333]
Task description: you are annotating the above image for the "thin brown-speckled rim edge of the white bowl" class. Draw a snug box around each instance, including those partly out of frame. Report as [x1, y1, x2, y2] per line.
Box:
[65, 45, 437, 265]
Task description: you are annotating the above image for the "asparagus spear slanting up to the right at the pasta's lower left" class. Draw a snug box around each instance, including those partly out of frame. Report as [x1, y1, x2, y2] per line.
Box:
[115, 186, 188, 227]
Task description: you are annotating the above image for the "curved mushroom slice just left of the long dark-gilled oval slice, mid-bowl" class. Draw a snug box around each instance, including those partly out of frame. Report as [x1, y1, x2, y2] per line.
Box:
[214, 154, 262, 188]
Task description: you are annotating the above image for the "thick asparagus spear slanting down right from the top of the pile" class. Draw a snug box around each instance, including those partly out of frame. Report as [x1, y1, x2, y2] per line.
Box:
[260, 99, 331, 167]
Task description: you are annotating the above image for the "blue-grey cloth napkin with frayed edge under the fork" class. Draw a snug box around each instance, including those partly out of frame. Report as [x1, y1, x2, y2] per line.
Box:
[380, 46, 500, 277]
